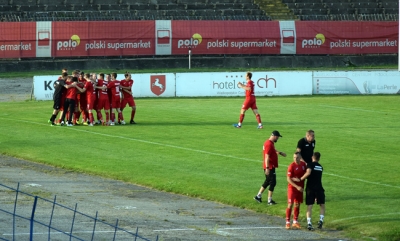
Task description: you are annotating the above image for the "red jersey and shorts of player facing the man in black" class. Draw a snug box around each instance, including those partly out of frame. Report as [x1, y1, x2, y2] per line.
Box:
[287, 162, 307, 203]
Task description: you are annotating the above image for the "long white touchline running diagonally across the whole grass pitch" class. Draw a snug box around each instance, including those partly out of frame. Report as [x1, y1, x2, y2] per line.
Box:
[0, 118, 400, 189]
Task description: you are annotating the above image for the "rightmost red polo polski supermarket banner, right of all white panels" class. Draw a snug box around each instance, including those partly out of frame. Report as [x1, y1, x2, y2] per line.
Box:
[295, 21, 399, 54]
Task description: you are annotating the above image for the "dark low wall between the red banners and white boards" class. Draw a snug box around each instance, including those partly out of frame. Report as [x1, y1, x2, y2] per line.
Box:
[0, 54, 398, 72]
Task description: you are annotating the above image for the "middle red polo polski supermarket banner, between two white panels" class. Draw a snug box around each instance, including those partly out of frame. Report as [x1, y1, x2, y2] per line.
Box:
[172, 20, 281, 55]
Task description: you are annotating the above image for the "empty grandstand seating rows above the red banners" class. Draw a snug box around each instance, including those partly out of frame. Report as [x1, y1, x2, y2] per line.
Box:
[0, 0, 398, 22]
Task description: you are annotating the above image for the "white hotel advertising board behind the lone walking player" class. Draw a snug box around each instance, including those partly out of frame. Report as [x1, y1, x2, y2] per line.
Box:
[176, 71, 312, 97]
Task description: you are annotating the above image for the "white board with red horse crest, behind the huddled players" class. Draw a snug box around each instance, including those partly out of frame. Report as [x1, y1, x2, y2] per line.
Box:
[33, 73, 175, 100]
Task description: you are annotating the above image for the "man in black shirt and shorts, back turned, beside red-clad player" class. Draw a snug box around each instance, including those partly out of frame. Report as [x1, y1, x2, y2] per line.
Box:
[300, 152, 325, 230]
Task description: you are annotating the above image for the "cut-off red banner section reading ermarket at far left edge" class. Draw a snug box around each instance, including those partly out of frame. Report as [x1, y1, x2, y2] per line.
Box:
[0, 22, 36, 58]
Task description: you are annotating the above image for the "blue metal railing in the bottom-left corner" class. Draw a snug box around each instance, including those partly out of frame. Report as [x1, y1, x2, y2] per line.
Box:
[0, 183, 158, 241]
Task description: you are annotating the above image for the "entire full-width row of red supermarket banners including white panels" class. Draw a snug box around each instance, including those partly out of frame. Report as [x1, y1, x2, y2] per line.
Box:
[0, 20, 399, 58]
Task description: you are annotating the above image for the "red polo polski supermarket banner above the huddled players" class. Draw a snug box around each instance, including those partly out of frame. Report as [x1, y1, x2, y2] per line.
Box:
[52, 21, 155, 57]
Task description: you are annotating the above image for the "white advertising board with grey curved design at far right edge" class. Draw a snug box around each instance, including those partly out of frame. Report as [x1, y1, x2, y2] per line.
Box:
[313, 71, 400, 94]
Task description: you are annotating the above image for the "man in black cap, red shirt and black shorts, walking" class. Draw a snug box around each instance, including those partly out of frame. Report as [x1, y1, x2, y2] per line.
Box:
[254, 130, 286, 205]
